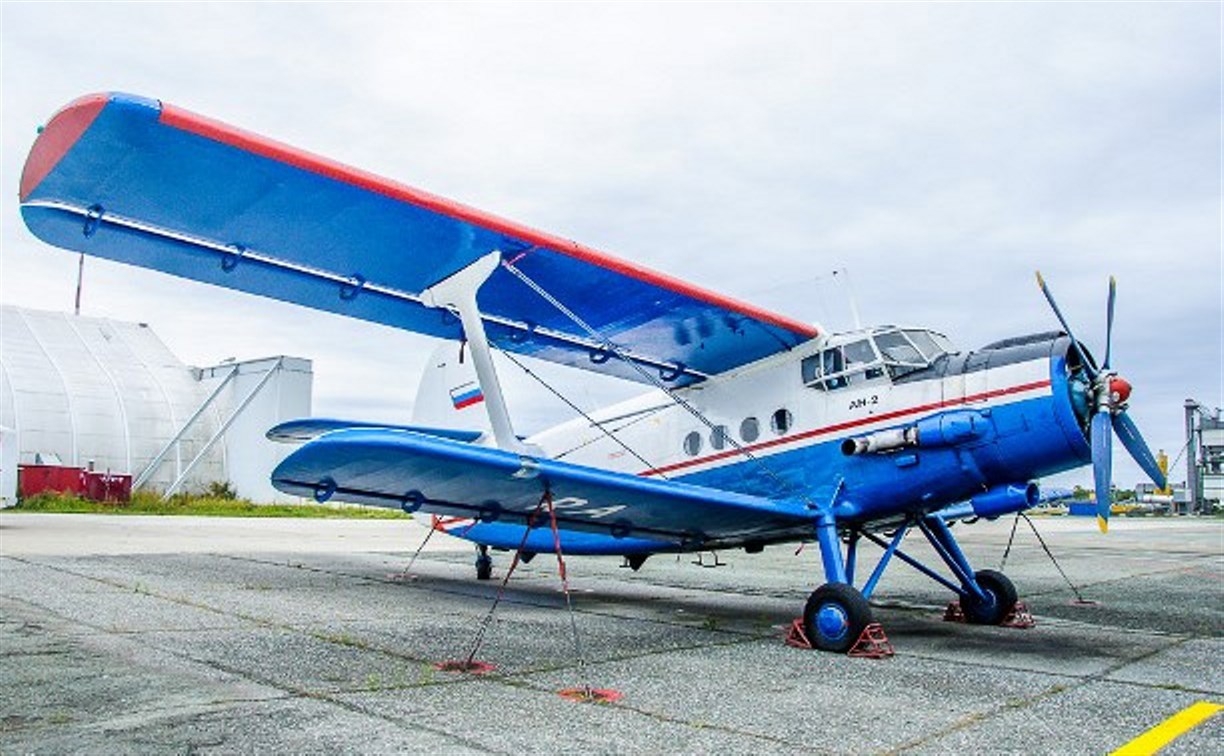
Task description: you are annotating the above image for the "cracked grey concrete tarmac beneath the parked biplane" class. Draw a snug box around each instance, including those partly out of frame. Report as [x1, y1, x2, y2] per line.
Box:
[0, 513, 1224, 754]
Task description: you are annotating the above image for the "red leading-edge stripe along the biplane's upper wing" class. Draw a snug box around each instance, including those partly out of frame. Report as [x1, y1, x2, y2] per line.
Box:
[160, 103, 820, 339]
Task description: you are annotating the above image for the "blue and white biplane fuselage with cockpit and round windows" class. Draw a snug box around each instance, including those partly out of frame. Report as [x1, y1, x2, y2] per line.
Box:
[428, 327, 1091, 554]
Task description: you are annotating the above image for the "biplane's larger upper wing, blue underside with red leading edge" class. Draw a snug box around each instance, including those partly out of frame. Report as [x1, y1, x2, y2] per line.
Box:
[21, 94, 816, 385]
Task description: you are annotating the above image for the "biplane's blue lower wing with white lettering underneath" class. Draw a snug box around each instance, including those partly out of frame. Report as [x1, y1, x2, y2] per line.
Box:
[272, 429, 815, 548]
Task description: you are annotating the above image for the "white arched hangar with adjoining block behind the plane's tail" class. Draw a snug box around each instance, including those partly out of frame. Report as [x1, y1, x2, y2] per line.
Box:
[0, 306, 312, 504]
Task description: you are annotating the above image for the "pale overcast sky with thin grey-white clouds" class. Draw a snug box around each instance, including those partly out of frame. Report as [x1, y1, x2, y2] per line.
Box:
[0, 1, 1224, 487]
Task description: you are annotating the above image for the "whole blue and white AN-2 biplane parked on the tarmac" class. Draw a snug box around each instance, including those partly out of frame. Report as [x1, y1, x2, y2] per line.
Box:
[21, 94, 1164, 651]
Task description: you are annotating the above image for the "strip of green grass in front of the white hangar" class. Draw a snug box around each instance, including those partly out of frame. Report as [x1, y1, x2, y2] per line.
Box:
[9, 484, 408, 520]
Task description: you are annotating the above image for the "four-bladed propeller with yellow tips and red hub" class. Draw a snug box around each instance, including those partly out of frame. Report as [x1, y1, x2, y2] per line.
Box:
[1037, 272, 1166, 533]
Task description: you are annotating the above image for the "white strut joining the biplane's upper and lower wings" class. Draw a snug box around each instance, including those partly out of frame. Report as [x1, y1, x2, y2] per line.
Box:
[421, 250, 528, 454]
